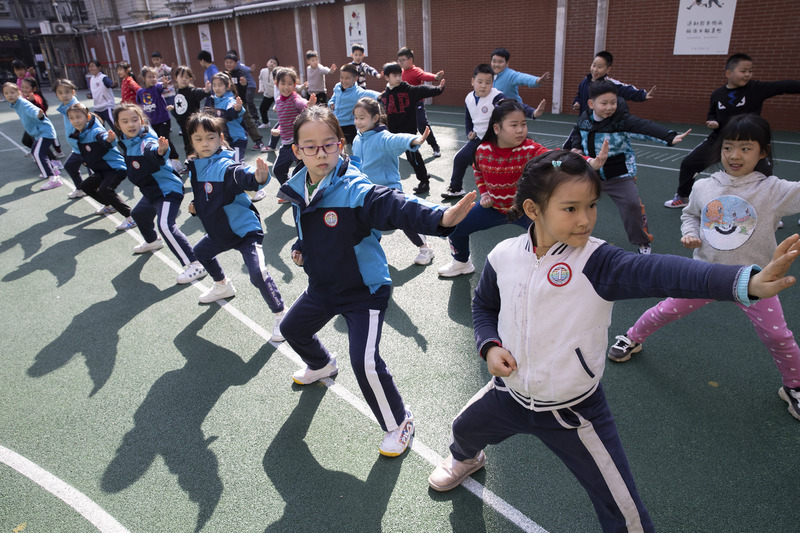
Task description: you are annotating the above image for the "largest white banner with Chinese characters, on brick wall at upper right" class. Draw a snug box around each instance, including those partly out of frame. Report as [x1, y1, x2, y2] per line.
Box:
[672, 0, 736, 55]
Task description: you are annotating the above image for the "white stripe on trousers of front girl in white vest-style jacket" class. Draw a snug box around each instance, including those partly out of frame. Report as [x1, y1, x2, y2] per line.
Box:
[553, 411, 644, 533]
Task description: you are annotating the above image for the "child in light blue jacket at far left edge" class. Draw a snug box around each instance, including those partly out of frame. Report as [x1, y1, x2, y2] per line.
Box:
[3, 82, 61, 191]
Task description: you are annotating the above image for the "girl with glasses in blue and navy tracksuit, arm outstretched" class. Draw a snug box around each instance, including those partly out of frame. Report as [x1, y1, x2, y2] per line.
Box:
[278, 106, 474, 457]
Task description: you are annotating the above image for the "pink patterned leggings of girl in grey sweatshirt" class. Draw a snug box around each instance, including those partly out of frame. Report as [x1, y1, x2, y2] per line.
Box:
[627, 296, 800, 388]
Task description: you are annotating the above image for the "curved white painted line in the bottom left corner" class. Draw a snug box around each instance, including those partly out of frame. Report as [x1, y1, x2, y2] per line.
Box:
[0, 446, 130, 533]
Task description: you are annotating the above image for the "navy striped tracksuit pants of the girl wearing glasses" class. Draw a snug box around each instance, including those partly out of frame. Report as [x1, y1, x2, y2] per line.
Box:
[281, 285, 406, 431]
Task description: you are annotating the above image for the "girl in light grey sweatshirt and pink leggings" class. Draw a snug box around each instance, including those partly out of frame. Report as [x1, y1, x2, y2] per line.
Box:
[608, 115, 800, 419]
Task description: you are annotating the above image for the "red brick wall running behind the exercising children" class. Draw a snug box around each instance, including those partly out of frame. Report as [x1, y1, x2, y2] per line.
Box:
[87, 0, 800, 130]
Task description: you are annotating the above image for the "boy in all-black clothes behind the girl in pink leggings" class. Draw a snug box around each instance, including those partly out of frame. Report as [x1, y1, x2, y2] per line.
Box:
[664, 54, 800, 209]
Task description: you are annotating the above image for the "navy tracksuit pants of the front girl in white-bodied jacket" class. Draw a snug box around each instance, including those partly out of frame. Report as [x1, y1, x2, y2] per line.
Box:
[450, 378, 654, 533]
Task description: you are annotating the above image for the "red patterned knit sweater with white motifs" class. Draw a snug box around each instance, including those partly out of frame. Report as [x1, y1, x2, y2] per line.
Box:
[472, 139, 550, 213]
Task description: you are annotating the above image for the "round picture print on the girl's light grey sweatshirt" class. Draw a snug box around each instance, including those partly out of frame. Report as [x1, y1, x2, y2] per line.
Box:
[700, 196, 758, 250]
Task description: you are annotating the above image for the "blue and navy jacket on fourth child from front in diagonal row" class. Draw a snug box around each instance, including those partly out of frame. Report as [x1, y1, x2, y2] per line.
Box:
[117, 126, 183, 202]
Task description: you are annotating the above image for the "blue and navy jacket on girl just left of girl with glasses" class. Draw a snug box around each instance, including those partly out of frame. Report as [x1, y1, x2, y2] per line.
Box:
[189, 149, 269, 247]
